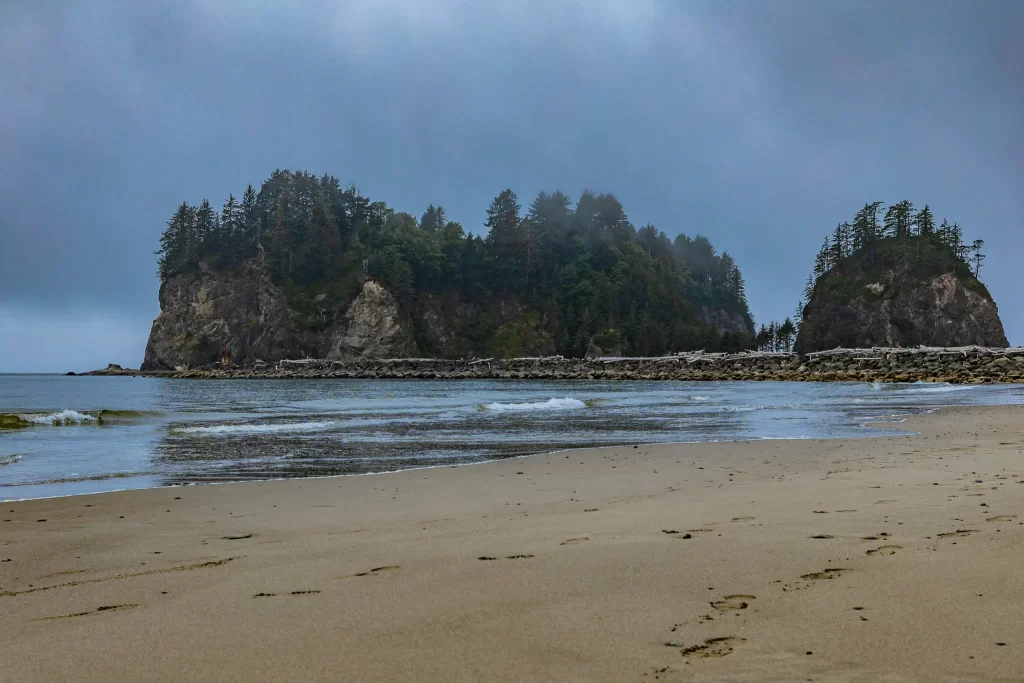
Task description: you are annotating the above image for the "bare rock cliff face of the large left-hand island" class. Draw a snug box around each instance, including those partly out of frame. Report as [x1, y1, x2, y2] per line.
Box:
[141, 262, 750, 372]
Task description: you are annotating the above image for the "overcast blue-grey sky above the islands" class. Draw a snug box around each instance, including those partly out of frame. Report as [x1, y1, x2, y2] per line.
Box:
[0, 0, 1024, 372]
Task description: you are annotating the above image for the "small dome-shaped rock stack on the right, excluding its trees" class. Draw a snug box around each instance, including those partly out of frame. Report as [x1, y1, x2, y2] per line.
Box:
[797, 237, 1009, 353]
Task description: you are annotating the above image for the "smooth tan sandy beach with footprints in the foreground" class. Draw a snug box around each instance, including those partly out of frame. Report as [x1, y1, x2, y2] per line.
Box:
[0, 408, 1024, 683]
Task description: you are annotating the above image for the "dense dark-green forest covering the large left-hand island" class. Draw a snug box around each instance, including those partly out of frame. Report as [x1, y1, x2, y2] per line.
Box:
[157, 170, 754, 356]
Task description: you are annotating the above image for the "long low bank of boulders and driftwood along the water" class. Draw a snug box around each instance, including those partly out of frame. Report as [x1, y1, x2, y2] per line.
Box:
[104, 346, 1024, 384]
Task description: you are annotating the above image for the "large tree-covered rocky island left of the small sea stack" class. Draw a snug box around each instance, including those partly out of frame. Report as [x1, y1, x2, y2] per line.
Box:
[142, 171, 754, 372]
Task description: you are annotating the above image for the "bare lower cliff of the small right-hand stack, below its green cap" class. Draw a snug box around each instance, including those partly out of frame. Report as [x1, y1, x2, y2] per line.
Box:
[797, 270, 1008, 353]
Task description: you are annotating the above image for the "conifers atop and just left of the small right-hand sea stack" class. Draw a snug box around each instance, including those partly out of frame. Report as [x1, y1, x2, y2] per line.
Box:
[756, 200, 990, 351]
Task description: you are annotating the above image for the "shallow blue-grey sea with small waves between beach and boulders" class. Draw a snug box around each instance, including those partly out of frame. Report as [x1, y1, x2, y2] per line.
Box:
[0, 375, 1024, 501]
